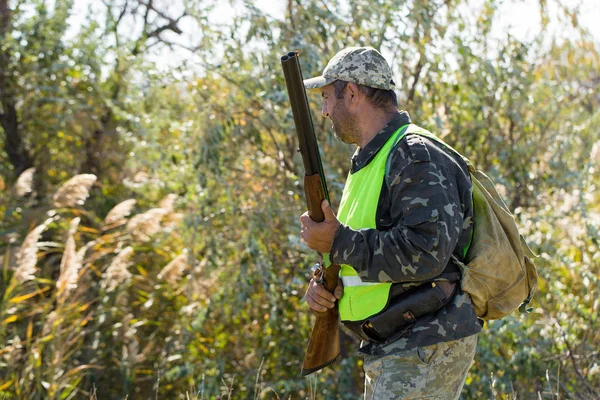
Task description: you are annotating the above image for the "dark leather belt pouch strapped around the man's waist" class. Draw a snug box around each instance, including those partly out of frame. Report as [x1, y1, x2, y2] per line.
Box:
[362, 283, 447, 343]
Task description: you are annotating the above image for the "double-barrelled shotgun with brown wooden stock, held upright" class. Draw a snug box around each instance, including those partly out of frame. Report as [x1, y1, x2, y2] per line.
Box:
[281, 51, 341, 376]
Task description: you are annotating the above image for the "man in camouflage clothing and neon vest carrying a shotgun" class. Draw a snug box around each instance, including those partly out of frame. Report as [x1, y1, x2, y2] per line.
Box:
[300, 47, 481, 399]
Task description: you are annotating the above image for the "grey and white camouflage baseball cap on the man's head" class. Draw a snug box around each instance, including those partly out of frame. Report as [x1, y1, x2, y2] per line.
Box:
[304, 47, 395, 90]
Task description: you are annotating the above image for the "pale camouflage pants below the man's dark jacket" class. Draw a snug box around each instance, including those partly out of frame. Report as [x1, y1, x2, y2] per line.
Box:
[364, 335, 477, 400]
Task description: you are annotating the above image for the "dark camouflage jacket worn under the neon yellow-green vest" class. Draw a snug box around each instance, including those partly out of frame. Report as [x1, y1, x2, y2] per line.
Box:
[330, 111, 481, 355]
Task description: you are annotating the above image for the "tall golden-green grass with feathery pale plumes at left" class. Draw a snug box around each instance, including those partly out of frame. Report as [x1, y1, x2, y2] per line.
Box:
[0, 171, 209, 399]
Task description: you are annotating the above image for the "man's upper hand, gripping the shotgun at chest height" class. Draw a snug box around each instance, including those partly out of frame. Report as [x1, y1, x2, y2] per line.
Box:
[300, 200, 341, 253]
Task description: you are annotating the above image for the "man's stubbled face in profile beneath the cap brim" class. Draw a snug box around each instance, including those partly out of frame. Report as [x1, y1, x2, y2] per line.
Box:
[321, 84, 359, 144]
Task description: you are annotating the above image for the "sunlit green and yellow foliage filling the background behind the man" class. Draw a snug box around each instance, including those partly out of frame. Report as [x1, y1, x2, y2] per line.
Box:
[0, 0, 600, 399]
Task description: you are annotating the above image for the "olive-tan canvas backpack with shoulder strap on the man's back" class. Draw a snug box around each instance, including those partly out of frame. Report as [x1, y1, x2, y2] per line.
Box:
[386, 124, 537, 320]
